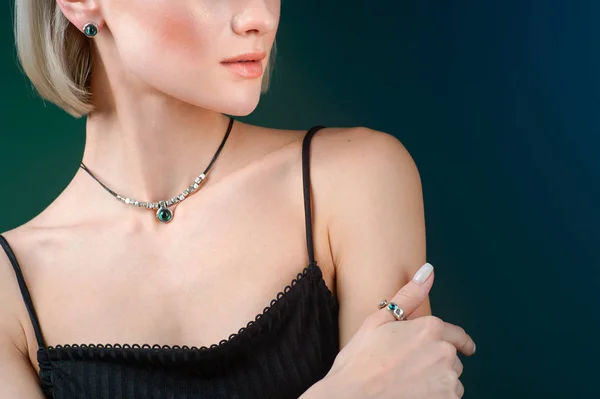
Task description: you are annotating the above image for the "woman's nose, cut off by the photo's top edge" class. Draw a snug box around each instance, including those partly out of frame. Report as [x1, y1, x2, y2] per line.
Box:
[232, 0, 278, 36]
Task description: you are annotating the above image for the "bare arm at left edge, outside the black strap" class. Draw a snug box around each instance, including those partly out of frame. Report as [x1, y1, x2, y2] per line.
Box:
[0, 248, 43, 399]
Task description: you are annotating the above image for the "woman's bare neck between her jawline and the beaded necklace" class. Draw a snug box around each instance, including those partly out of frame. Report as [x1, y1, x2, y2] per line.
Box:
[82, 96, 236, 206]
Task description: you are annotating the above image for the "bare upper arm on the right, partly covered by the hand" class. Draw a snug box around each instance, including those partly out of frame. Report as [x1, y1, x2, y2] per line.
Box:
[328, 128, 431, 349]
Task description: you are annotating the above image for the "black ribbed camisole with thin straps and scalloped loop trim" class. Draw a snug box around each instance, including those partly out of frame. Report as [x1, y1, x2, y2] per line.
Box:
[0, 126, 339, 399]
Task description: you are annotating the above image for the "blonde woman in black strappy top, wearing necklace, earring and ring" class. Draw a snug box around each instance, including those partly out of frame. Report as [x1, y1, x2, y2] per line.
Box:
[0, 0, 474, 399]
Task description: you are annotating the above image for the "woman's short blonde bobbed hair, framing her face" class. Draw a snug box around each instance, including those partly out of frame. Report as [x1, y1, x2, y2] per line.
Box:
[15, 0, 276, 118]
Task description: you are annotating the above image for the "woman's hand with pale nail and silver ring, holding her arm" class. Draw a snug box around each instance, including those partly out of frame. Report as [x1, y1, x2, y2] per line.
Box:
[321, 264, 475, 399]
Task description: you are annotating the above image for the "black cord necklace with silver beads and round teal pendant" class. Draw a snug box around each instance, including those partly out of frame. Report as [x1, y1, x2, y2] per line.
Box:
[79, 117, 234, 223]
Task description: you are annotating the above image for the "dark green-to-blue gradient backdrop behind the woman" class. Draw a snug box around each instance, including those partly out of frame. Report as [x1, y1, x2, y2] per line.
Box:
[0, 0, 600, 399]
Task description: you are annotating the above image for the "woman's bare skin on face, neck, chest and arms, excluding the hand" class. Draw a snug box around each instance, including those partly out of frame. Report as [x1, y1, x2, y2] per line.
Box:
[0, 0, 431, 398]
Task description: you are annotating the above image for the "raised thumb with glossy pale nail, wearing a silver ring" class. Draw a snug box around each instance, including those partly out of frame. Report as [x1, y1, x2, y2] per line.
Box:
[378, 263, 433, 323]
